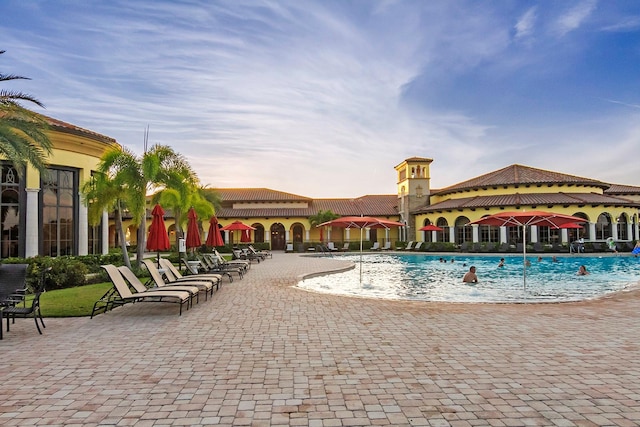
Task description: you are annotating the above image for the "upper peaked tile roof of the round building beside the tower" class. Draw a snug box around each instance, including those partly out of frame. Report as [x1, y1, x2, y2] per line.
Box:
[432, 165, 609, 195]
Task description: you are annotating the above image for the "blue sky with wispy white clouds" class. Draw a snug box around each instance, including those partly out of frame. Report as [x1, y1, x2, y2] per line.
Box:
[0, 0, 640, 198]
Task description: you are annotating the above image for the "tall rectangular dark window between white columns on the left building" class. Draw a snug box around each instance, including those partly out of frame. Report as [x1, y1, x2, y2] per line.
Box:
[41, 169, 78, 256]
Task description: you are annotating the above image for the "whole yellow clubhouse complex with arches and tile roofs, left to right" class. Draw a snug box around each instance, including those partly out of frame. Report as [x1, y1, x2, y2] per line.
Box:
[0, 119, 640, 258]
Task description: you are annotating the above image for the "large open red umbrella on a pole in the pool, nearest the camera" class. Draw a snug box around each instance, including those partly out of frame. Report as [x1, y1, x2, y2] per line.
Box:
[467, 211, 585, 290]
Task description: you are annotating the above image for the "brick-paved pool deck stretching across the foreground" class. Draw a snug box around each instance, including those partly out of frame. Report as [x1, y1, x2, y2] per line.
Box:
[0, 253, 640, 426]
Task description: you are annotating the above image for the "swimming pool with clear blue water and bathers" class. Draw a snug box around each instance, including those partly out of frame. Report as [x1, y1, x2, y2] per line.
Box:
[298, 254, 640, 302]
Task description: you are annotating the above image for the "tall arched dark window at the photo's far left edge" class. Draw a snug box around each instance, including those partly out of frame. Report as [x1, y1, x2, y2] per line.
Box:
[0, 164, 20, 258]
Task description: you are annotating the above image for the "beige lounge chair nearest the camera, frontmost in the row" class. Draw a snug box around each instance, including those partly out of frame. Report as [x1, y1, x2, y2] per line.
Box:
[99, 264, 192, 317]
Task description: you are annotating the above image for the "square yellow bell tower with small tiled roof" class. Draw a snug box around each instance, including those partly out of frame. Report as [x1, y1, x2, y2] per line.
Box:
[395, 157, 433, 240]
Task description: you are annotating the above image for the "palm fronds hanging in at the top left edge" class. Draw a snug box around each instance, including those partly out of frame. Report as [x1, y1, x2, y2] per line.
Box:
[0, 50, 53, 176]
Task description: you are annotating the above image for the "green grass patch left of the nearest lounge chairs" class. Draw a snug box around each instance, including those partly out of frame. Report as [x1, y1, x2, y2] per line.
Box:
[40, 283, 113, 317]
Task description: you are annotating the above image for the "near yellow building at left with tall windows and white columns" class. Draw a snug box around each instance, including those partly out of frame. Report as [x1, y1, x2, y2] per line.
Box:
[0, 118, 118, 258]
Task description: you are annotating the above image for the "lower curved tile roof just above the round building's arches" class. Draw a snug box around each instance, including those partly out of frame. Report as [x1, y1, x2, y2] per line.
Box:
[412, 193, 640, 214]
